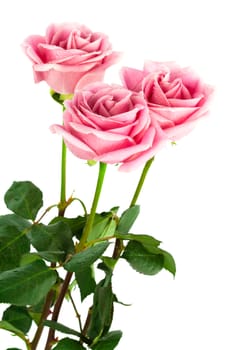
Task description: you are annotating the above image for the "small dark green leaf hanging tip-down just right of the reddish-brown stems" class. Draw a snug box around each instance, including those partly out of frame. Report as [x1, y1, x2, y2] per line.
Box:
[75, 266, 96, 301]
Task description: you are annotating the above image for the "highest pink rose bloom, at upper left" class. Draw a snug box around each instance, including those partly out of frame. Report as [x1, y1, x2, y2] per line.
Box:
[22, 23, 120, 94]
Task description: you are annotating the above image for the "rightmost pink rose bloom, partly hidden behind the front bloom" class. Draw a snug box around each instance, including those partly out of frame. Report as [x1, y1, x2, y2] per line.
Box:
[121, 61, 213, 141]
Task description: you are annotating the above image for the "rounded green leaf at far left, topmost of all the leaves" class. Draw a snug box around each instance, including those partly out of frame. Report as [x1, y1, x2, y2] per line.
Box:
[4, 181, 43, 220]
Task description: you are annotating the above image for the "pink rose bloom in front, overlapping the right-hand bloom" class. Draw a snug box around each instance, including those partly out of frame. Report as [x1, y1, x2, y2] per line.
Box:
[51, 82, 164, 171]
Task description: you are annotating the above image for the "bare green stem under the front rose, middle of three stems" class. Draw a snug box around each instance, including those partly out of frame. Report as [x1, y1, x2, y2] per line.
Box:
[78, 162, 107, 251]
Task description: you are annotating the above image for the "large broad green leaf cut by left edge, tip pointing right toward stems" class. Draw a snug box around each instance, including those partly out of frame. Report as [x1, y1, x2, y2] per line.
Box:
[0, 260, 57, 306]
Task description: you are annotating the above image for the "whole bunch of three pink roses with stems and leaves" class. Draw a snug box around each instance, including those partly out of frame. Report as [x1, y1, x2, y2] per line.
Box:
[0, 23, 213, 350]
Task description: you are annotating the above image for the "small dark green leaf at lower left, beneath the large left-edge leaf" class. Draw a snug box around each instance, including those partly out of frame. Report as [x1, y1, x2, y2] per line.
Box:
[2, 305, 32, 334]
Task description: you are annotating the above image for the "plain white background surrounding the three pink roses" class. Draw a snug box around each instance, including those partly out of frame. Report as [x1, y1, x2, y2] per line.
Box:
[0, 0, 233, 350]
